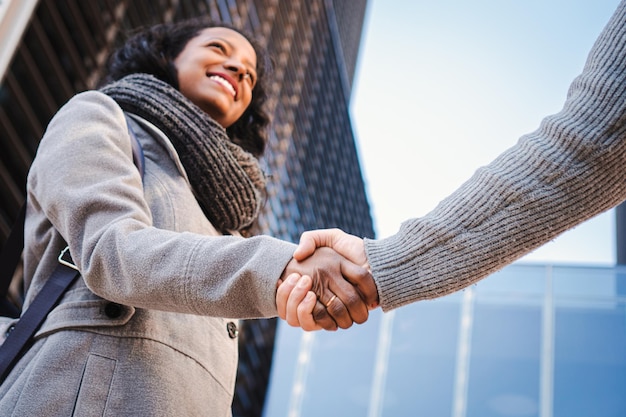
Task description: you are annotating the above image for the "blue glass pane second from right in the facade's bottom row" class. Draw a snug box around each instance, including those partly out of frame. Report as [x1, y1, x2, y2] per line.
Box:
[467, 298, 541, 417]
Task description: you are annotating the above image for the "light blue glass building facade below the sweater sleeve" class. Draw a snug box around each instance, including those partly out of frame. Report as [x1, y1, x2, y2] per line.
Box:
[265, 263, 626, 417]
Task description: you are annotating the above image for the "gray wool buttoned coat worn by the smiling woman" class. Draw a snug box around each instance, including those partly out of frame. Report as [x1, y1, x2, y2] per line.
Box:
[0, 91, 295, 417]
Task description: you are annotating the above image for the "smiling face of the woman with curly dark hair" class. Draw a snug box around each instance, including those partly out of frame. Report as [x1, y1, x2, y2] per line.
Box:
[174, 27, 256, 128]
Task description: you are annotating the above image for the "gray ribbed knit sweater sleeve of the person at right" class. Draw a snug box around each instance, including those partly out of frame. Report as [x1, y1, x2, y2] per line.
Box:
[365, 0, 626, 311]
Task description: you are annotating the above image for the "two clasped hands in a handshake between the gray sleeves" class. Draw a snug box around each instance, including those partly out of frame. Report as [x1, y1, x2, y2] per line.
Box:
[276, 229, 378, 331]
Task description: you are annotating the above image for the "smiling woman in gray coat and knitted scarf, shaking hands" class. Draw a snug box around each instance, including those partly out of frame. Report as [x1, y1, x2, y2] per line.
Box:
[0, 20, 375, 416]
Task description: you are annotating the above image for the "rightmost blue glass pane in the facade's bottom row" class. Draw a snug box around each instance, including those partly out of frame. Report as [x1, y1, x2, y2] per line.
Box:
[554, 302, 626, 417]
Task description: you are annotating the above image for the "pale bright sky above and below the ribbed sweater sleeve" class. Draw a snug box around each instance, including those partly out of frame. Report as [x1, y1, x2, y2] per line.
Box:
[351, 0, 619, 264]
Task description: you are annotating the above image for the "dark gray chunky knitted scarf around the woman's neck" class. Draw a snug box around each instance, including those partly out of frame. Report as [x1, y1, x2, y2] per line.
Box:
[101, 74, 265, 232]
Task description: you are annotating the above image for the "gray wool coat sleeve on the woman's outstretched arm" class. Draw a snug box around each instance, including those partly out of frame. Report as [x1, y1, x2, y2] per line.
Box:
[28, 91, 295, 318]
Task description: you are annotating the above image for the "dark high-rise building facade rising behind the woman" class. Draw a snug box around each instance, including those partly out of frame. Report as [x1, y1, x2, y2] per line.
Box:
[0, 0, 374, 416]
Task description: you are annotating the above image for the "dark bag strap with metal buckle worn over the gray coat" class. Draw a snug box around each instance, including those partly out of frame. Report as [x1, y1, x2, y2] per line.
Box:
[0, 116, 145, 384]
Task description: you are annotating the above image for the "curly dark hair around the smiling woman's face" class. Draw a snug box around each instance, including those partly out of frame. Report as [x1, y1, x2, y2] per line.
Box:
[100, 17, 272, 157]
